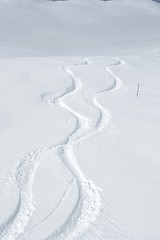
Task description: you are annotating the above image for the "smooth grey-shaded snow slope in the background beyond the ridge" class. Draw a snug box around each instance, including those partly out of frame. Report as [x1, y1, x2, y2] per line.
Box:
[0, 0, 160, 57]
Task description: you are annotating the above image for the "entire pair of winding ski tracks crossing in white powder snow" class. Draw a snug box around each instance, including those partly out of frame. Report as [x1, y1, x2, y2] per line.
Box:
[0, 58, 129, 240]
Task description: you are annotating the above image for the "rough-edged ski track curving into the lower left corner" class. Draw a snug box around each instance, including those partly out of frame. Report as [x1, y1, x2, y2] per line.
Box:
[0, 148, 47, 240]
